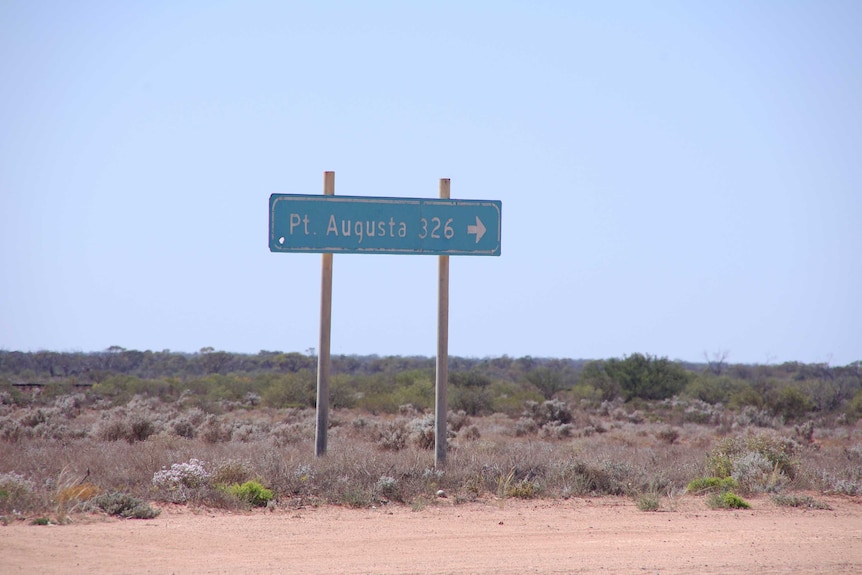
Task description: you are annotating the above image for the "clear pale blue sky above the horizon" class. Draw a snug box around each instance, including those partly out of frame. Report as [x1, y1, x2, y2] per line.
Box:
[0, 0, 862, 365]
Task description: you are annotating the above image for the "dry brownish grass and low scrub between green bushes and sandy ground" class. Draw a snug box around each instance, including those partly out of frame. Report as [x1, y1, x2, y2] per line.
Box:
[0, 397, 862, 521]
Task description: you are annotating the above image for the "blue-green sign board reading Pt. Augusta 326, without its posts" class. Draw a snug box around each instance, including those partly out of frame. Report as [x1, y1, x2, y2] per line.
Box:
[269, 194, 502, 256]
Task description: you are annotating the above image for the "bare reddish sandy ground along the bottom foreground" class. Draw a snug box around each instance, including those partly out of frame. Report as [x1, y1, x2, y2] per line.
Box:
[0, 497, 862, 575]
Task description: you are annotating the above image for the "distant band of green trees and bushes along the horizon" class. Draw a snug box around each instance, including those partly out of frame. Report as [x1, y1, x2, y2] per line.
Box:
[0, 346, 862, 421]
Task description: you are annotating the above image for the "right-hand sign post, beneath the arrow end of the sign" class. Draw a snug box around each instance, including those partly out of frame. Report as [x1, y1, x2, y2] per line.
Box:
[434, 178, 449, 467]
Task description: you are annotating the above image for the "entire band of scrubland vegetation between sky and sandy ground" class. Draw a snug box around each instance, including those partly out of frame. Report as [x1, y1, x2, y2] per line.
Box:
[0, 348, 862, 523]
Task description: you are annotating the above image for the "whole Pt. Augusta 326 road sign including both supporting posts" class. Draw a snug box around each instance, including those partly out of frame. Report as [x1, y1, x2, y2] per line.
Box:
[269, 172, 502, 465]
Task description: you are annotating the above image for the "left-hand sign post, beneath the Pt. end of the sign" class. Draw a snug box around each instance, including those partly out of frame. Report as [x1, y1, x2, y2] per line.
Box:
[314, 172, 335, 457]
